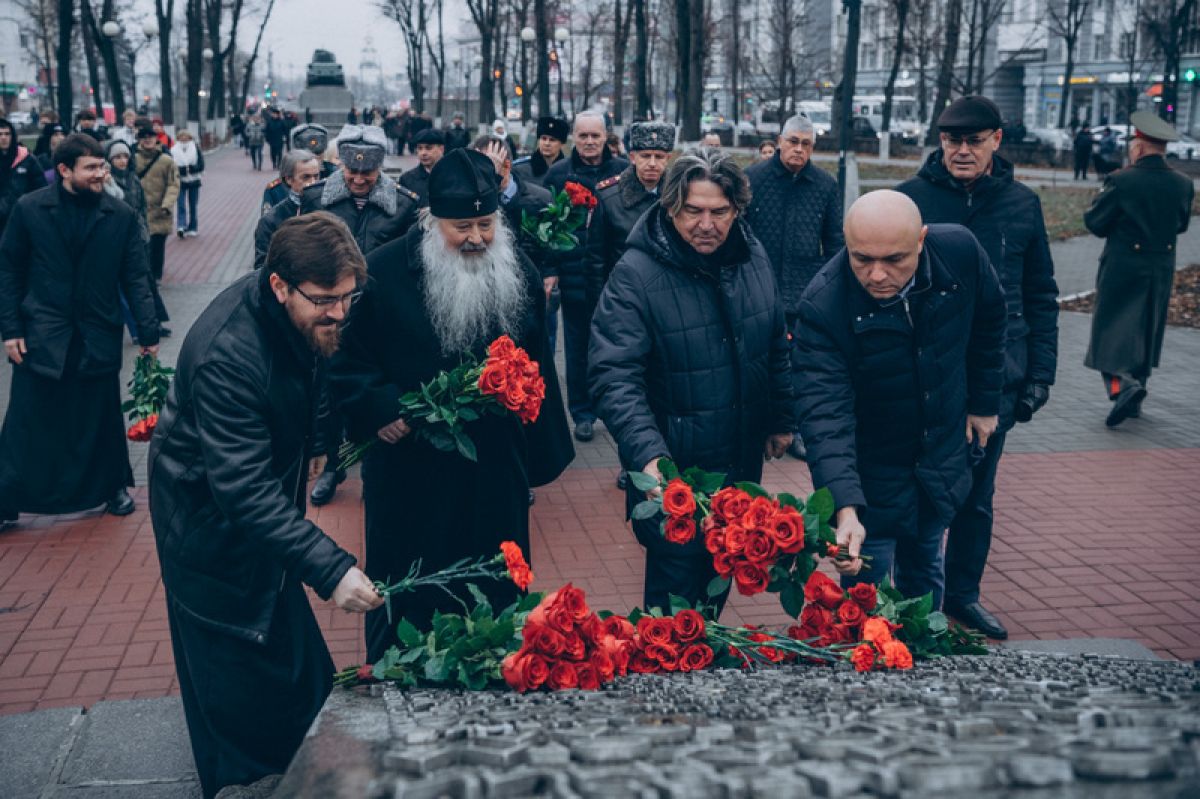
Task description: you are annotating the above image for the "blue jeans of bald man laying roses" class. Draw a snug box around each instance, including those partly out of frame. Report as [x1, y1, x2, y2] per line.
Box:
[841, 489, 946, 611]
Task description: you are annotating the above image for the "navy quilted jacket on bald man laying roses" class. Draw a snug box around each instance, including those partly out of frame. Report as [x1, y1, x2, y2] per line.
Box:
[794, 224, 1004, 525]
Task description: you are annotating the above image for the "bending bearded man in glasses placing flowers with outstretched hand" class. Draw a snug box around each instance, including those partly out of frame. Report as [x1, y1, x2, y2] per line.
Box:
[149, 214, 383, 797]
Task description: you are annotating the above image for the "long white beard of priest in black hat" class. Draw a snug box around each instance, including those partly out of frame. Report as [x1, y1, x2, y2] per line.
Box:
[421, 214, 529, 356]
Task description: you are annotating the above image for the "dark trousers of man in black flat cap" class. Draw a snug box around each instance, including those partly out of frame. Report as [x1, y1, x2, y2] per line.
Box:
[946, 431, 1008, 605]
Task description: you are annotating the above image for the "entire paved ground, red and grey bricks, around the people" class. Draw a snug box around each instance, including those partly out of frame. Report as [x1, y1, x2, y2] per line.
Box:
[0, 149, 1200, 714]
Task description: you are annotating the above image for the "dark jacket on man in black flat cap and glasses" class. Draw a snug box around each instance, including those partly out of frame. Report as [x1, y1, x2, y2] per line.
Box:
[896, 150, 1058, 417]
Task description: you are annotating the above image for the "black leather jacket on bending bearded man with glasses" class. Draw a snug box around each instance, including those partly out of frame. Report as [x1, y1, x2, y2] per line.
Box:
[149, 270, 355, 643]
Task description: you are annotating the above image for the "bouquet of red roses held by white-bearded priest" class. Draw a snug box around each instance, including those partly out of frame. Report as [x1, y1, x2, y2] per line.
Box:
[338, 336, 546, 469]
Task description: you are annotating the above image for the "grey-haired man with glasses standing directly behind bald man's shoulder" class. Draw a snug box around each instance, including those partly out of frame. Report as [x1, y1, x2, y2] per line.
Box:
[746, 114, 845, 458]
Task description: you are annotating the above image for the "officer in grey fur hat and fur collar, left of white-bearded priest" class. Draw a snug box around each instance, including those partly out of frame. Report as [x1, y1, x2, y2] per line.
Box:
[300, 125, 420, 505]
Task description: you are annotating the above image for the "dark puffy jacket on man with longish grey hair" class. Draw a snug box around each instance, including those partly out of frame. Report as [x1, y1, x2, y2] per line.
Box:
[588, 208, 793, 547]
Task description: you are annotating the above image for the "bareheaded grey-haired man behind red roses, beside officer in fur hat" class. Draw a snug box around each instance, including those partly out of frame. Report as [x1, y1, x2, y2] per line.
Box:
[544, 112, 629, 441]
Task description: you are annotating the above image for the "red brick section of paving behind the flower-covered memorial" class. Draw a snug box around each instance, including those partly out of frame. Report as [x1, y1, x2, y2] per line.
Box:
[0, 450, 1200, 714]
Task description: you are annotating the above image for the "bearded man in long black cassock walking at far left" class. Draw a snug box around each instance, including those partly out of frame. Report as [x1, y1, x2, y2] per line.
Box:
[0, 133, 158, 527]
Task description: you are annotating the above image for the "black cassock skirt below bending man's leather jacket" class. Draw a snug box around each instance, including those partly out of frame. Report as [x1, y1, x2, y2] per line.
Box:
[167, 581, 334, 798]
